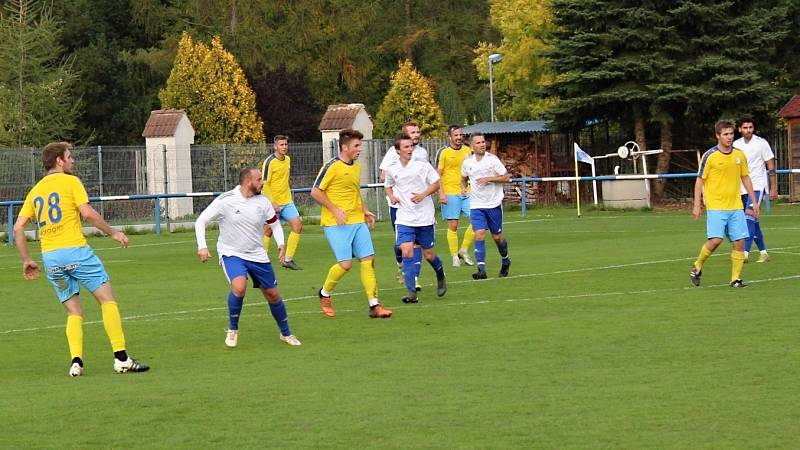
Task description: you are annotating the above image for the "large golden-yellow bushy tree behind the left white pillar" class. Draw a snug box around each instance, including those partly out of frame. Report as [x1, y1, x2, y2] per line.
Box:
[159, 33, 264, 144]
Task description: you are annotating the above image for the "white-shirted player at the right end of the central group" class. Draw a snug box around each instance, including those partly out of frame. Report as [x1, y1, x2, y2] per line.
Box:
[461, 133, 511, 280]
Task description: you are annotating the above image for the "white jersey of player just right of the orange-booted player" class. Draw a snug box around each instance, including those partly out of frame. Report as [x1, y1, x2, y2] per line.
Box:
[386, 160, 439, 227]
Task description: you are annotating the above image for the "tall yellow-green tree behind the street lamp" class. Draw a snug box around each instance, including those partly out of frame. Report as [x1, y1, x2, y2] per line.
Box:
[472, 0, 553, 120]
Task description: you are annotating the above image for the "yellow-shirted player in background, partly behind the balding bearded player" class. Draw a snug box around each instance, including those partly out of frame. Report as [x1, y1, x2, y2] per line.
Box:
[261, 134, 303, 270]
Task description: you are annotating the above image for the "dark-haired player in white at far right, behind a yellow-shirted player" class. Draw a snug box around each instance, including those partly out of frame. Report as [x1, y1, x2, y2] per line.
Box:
[733, 117, 778, 262]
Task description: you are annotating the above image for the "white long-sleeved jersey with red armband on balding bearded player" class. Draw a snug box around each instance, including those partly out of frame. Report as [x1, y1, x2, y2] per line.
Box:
[194, 186, 283, 262]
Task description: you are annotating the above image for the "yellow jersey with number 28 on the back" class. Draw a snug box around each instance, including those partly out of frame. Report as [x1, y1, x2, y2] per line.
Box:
[19, 173, 89, 253]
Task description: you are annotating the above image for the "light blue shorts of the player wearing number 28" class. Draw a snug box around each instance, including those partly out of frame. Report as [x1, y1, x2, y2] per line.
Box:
[42, 245, 108, 303]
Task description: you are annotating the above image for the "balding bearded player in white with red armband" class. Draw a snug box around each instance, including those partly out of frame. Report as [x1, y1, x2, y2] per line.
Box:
[194, 167, 300, 348]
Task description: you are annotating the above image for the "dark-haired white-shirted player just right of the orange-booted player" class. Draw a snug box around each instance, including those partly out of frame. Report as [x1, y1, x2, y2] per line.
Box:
[384, 133, 447, 303]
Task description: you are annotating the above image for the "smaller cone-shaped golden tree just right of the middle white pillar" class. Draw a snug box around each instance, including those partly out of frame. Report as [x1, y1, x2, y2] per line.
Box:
[375, 60, 445, 137]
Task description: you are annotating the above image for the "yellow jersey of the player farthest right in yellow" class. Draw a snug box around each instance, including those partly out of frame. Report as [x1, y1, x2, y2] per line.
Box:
[697, 146, 750, 211]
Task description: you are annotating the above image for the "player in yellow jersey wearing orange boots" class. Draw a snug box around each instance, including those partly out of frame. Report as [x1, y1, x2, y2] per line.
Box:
[311, 129, 392, 319]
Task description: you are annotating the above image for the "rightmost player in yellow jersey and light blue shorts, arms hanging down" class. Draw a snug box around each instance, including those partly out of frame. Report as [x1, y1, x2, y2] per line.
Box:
[689, 120, 760, 288]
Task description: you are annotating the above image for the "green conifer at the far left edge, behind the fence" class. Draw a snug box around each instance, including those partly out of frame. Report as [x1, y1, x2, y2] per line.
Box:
[0, 0, 81, 147]
